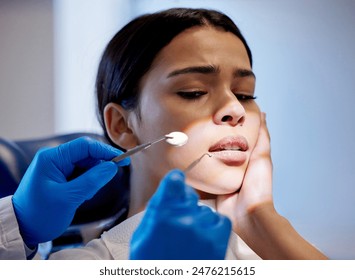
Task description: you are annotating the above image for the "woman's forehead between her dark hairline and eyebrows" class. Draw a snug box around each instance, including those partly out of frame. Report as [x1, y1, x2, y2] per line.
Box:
[151, 26, 251, 76]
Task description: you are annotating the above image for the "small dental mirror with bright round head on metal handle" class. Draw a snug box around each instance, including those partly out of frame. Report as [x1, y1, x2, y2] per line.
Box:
[111, 131, 188, 162]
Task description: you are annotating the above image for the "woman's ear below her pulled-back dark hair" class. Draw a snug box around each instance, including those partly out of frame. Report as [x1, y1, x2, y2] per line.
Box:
[104, 103, 137, 150]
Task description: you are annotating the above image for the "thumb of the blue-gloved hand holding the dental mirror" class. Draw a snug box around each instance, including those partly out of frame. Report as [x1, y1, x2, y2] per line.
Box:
[67, 161, 118, 202]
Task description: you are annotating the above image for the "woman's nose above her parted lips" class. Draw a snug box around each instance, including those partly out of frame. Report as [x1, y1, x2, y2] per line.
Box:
[214, 95, 245, 126]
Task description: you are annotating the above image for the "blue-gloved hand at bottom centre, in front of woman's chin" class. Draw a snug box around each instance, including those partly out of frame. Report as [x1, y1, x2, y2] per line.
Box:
[130, 170, 231, 260]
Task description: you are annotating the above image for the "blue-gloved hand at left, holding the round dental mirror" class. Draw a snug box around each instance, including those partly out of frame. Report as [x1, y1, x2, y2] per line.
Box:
[12, 137, 129, 247]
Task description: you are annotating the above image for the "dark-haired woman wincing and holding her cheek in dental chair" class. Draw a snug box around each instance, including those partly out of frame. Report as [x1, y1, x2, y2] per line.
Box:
[50, 9, 325, 259]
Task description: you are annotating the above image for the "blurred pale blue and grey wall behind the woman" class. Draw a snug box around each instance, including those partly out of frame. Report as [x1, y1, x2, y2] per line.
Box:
[0, 0, 355, 259]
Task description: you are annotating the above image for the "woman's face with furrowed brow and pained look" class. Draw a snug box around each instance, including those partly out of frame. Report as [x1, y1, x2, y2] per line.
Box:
[129, 27, 260, 194]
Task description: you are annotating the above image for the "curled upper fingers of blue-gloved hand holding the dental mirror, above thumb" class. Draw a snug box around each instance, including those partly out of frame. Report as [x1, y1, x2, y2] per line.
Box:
[51, 137, 130, 176]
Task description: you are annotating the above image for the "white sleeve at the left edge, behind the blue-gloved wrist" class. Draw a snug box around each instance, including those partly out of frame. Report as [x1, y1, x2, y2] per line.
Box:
[0, 196, 26, 260]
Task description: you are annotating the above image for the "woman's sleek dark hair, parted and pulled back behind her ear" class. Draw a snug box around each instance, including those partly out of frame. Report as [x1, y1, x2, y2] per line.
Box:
[96, 8, 252, 145]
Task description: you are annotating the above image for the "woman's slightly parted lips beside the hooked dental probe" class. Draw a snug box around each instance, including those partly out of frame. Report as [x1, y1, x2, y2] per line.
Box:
[208, 136, 249, 166]
